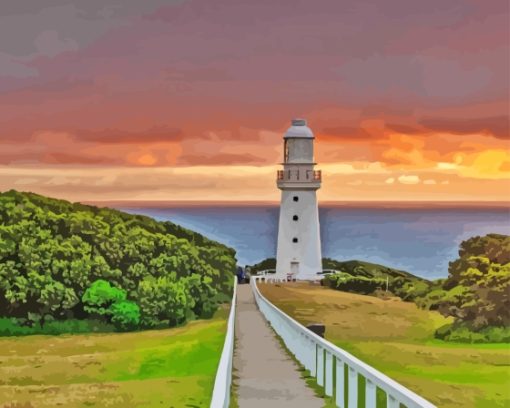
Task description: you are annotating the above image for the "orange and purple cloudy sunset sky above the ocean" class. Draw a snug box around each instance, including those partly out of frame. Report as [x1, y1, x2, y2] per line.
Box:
[0, 0, 510, 201]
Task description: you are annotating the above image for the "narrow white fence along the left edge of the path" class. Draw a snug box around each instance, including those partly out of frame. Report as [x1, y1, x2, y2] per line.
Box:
[211, 279, 237, 408]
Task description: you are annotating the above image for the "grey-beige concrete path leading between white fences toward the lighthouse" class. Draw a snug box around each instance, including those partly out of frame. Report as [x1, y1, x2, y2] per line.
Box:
[233, 285, 324, 408]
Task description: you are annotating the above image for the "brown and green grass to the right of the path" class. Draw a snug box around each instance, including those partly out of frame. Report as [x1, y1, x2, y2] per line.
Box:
[260, 283, 510, 408]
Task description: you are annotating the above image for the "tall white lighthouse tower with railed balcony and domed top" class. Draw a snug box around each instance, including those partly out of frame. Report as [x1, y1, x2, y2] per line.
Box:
[276, 119, 322, 280]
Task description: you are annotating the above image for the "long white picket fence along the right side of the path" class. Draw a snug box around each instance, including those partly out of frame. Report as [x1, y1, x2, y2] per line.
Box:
[251, 277, 435, 408]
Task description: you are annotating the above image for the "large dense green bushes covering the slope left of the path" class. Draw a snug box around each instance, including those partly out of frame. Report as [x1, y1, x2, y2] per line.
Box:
[0, 191, 236, 330]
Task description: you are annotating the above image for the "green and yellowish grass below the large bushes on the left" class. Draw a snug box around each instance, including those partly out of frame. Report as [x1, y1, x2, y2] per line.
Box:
[0, 310, 226, 408]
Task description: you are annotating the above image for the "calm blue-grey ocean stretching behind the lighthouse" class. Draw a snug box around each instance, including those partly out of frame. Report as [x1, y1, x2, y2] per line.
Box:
[116, 205, 510, 279]
